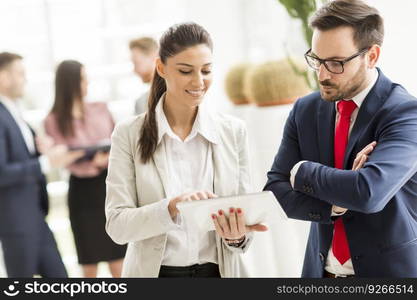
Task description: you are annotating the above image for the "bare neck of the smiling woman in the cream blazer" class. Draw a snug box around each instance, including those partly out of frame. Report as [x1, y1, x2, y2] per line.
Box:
[163, 94, 198, 141]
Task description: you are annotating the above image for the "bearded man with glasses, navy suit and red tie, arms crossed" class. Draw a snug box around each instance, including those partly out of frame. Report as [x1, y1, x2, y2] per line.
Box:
[265, 0, 417, 277]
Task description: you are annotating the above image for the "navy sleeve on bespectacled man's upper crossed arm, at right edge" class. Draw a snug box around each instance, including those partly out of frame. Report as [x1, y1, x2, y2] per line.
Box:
[294, 101, 417, 214]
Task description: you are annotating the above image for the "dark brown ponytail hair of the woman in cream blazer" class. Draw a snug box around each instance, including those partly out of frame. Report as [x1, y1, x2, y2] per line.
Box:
[138, 23, 213, 163]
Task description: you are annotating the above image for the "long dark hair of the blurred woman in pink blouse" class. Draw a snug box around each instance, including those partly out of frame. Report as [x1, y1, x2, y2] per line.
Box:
[51, 60, 83, 137]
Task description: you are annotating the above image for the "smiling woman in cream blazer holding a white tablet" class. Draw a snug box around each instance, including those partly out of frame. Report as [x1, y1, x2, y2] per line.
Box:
[106, 23, 266, 277]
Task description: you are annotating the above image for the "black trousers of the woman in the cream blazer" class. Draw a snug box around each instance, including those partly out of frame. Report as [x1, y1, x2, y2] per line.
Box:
[159, 263, 220, 278]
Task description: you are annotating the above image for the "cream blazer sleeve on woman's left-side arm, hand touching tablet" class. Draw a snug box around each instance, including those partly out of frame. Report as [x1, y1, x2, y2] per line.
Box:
[105, 123, 176, 244]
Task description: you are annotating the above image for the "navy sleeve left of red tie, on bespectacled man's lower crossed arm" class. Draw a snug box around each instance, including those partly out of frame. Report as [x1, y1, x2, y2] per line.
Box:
[264, 103, 332, 223]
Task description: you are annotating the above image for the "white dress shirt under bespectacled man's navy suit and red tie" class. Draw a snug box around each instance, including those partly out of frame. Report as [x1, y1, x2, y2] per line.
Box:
[290, 69, 378, 276]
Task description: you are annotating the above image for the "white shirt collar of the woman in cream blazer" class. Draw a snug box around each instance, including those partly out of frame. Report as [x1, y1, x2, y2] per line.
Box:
[155, 94, 219, 144]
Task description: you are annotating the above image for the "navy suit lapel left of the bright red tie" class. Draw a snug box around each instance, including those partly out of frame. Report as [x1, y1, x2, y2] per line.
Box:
[318, 100, 336, 167]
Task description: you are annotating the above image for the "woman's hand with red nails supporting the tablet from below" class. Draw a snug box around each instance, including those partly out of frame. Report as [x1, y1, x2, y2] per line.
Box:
[211, 207, 268, 244]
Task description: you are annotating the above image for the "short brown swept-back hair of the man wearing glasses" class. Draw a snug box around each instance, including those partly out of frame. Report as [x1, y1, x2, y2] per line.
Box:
[310, 0, 384, 49]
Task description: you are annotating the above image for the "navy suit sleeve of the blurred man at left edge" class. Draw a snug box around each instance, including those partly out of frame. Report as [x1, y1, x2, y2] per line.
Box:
[0, 127, 43, 187]
